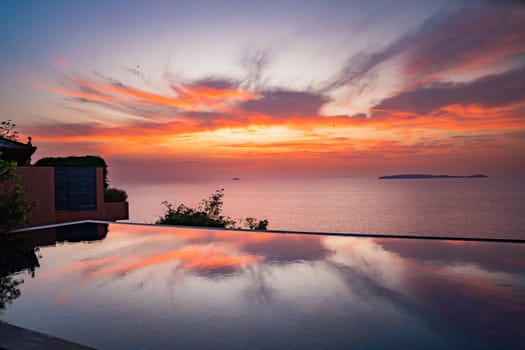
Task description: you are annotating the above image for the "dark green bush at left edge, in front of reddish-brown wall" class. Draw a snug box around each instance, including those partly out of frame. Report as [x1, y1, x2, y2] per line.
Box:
[0, 152, 35, 232]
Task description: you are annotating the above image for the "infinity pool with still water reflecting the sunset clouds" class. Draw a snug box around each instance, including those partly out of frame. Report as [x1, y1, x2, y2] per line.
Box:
[0, 224, 525, 349]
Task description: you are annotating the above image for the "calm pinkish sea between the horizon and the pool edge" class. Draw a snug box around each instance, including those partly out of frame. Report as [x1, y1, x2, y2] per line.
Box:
[121, 177, 525, 239]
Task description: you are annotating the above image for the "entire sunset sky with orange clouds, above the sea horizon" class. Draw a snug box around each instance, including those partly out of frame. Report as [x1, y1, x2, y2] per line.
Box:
[0, 0, 525, 183]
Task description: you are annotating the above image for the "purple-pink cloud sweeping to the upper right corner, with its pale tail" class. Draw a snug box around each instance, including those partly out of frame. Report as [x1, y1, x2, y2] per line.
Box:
[324, 2, 525, 91]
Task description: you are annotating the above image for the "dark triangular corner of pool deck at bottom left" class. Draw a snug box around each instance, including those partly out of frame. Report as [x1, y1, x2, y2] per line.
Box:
[0, 321, 95, 350]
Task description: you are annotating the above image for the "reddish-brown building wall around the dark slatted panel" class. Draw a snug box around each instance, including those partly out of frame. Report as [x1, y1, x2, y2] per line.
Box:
[17, 166, 129, 226]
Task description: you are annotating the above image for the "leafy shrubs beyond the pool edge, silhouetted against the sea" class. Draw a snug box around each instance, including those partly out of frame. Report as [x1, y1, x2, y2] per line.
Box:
[155, 189, 268, 230]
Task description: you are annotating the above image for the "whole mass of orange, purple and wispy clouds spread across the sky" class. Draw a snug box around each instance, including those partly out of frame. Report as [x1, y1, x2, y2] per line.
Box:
[24, 4, 525, 179]
